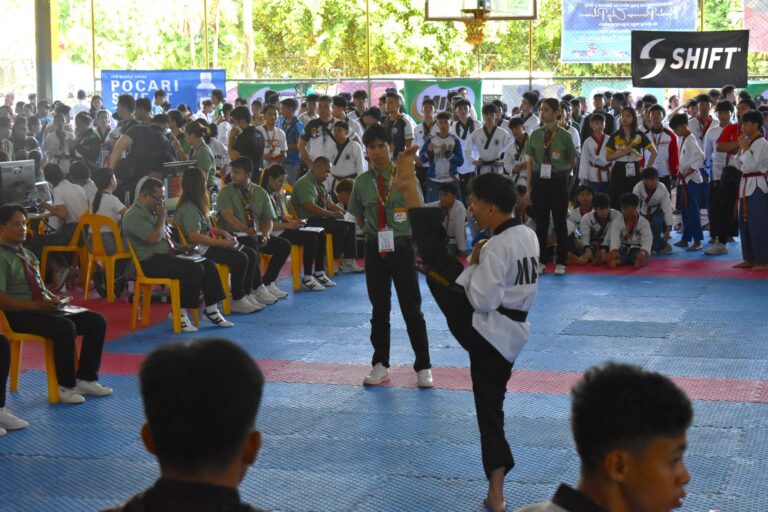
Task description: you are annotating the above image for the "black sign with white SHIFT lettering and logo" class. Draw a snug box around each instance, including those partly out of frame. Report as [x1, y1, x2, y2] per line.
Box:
[632, 30, 749, 88]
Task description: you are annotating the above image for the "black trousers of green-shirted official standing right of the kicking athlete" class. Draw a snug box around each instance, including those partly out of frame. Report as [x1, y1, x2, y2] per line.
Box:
[531, 174, 568, 265]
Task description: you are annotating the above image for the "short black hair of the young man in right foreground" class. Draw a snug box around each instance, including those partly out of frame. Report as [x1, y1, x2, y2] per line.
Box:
[571, 362, 693, 475]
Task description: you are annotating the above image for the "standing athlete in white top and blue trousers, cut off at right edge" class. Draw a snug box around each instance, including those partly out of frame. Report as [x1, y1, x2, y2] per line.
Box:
[736, 111, 768, 272]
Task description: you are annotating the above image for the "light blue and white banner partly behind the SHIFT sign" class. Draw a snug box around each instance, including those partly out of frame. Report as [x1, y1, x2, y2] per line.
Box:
[560, 0, 698, 63]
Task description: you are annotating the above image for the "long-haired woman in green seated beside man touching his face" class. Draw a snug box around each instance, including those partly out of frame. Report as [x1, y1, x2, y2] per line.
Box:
[173, 166, 265, 313]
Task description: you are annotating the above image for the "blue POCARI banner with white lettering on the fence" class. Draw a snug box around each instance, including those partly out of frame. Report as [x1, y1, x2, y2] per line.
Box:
[101, 69, 227, 112]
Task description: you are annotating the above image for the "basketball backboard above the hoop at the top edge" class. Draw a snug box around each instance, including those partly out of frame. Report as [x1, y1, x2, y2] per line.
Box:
[424, 0, 536, 21]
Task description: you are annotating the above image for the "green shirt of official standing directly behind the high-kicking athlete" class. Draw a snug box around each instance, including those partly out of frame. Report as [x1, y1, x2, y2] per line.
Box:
[347, 166, 421, 237]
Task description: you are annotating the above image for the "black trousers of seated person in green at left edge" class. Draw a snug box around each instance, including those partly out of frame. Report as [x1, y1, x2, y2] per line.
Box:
[3, 311, 107, 389]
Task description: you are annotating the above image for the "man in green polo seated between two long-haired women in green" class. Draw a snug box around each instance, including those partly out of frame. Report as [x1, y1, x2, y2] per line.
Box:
[216, 156, 291, 306]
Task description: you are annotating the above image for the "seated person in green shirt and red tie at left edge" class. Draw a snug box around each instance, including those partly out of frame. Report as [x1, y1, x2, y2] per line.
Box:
[0, 204, 112, 404]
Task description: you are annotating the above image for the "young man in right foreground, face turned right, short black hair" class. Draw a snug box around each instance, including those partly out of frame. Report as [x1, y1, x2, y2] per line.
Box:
[518, 363, 693, 512]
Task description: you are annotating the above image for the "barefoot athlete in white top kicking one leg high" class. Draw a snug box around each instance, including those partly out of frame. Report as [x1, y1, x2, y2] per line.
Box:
[396, 148, 539, 512]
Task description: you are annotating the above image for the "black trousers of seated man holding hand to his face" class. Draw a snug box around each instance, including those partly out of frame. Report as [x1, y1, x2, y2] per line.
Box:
[141, 254, 224, 308]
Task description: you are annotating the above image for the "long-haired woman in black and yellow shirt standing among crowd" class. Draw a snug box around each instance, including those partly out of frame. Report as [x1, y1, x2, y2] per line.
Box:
[605, 107, 656, 210]
